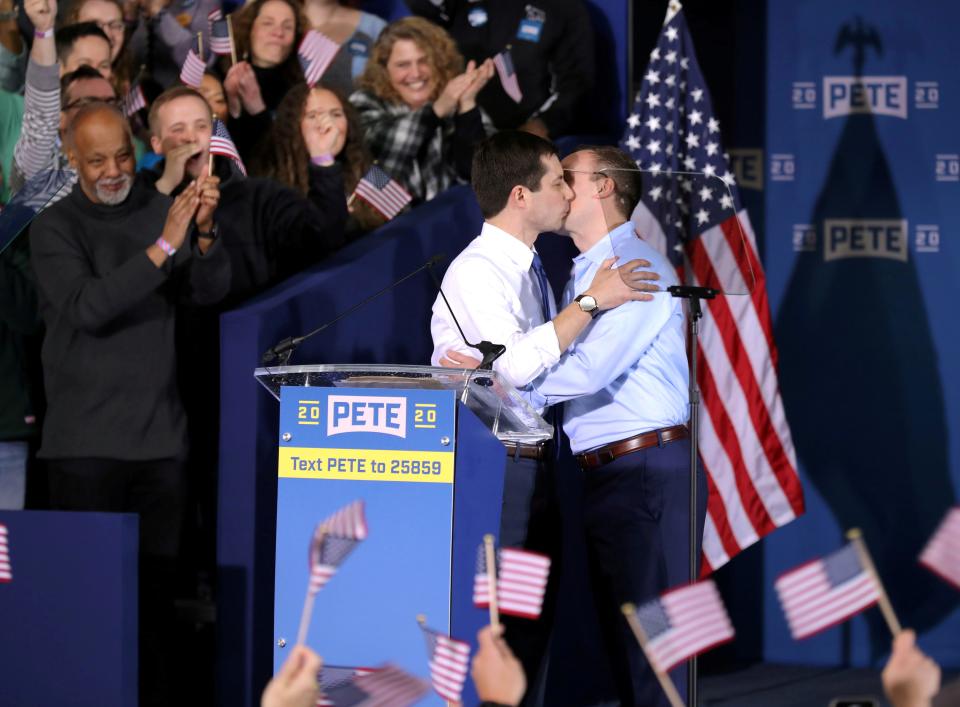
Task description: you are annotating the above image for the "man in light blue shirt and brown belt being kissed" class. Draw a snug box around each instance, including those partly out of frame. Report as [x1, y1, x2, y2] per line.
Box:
[525, 147, 706, 705]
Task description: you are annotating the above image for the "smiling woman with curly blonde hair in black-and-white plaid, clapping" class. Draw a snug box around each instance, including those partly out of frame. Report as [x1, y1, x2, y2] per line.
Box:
[350, 17, 494, 201]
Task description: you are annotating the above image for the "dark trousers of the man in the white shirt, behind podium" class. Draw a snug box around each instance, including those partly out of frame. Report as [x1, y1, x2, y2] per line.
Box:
[500, 455, 561, 705]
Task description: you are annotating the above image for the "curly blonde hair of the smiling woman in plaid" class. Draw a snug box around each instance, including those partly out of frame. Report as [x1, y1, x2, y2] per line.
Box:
[357, 17, 463, 103]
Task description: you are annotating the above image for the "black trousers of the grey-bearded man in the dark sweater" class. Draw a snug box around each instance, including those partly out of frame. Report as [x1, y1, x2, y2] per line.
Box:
[46, 459, 183, 706]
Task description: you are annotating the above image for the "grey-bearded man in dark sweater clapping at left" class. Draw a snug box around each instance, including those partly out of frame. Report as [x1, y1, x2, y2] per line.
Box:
[30, 103, 230, 705]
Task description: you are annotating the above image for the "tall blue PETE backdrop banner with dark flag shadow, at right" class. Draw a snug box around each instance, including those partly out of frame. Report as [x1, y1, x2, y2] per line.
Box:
[763, 0, 960, 667]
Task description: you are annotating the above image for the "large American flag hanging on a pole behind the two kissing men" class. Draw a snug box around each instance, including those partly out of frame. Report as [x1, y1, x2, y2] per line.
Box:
[621, 2, 804, 573]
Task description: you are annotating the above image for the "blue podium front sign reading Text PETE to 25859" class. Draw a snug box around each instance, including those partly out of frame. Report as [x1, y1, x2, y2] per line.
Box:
[274, 387, 456, 704]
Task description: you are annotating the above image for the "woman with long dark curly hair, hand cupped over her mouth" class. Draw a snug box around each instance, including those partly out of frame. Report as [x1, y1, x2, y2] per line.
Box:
[253, 82, 386, 237]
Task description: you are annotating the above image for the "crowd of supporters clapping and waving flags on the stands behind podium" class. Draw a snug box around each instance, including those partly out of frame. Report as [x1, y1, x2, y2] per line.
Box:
[0, 0, 593, 704]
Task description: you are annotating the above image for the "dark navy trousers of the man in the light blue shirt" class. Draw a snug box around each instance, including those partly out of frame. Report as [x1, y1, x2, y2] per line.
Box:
[583, 439, 707, 707]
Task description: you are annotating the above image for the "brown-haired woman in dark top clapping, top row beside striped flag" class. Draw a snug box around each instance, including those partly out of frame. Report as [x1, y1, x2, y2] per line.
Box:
[220, 0, 308, 160]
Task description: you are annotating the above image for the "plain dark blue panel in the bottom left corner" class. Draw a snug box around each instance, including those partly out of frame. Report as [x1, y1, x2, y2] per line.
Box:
[0, 511, 138, 707]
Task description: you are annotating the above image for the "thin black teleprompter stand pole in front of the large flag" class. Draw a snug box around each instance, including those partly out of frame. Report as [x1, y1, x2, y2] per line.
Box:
[667, 285, 720, 707]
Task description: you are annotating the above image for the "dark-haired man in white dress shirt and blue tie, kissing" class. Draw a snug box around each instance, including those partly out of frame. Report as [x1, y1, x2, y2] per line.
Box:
[430, 131, 659, 700]
